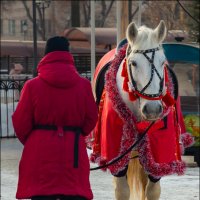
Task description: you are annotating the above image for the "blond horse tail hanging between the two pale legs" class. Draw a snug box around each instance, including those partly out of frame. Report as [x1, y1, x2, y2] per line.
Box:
[127, 152, 148, 200]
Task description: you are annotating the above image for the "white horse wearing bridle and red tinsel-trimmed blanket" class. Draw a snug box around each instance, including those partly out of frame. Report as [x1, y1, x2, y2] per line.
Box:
[92, 21, 193, 200]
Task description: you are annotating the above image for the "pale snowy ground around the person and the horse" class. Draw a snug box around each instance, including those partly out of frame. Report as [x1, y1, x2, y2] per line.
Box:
[0, 139, 199, 200]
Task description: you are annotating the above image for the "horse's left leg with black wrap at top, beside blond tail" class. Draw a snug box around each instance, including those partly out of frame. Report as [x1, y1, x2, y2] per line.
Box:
[114, 167, 130, 200]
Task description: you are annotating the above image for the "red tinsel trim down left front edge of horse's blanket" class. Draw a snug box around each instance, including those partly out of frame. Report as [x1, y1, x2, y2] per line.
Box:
[105, 45, 138, 174]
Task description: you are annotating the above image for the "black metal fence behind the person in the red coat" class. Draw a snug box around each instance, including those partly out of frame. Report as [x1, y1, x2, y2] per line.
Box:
[0, 55, 104, 138]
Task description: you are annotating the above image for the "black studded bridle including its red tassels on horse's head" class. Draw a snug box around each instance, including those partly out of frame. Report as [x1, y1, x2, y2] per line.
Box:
[121, 46, 176, 107]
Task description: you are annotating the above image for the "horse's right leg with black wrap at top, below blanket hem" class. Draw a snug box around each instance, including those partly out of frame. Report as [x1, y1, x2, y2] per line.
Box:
[145, 176, 161, 200]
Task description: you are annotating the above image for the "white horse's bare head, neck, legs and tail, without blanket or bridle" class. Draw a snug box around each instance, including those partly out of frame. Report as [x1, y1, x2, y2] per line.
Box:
[115, 21, 167, 200]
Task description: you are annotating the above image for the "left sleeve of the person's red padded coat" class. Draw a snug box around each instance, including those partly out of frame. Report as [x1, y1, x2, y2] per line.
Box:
[12, 81, 33, 144]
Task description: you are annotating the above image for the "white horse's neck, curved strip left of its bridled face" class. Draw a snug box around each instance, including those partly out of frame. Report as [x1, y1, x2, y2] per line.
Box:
[116, 61, 140, 117]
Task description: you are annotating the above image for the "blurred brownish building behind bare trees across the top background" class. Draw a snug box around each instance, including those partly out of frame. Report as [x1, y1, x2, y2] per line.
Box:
[1, 0, 199, 41]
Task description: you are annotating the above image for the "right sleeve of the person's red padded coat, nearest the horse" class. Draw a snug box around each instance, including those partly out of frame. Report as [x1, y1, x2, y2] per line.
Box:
[83, 82, 98, 135]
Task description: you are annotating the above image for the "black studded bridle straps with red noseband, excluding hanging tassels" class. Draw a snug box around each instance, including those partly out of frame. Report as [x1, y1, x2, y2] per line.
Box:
[128, 47, 165, 100]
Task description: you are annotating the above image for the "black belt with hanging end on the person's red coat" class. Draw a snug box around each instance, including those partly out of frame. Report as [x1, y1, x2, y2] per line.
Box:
[33, 124, 82, 168]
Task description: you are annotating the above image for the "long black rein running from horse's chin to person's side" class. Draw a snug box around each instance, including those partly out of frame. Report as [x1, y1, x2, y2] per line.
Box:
[90, 121, 155, 171]
